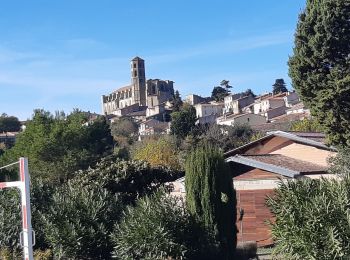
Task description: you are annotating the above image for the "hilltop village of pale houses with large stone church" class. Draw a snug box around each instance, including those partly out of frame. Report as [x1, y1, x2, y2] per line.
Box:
[101, 57, 310, 139]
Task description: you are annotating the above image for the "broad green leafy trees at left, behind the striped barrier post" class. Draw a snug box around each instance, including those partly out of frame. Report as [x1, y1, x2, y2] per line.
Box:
[0, 110, 113, 182]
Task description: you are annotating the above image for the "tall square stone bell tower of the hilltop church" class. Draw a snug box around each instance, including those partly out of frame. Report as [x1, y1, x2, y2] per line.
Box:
[131, 57, 146, 106]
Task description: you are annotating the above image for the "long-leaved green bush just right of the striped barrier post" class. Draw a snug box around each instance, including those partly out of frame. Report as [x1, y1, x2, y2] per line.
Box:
[42, 181, 122, 259]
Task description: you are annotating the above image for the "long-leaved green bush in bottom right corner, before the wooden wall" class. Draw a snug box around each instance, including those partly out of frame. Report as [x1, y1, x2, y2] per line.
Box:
[267, 176, 350, 260]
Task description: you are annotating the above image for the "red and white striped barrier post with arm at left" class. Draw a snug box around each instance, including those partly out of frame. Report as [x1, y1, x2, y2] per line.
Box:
[0, 157, 33, 260]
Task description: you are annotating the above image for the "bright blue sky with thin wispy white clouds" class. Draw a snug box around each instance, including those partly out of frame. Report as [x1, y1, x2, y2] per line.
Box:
[0, 0, 305, 120]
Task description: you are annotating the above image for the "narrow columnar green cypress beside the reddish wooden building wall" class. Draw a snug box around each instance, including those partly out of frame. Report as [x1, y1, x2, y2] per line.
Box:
[185, 145, 237, 259]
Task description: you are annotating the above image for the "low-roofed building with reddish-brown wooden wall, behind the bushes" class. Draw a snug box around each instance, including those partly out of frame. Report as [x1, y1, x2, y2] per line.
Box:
[225, 131, 336, 246]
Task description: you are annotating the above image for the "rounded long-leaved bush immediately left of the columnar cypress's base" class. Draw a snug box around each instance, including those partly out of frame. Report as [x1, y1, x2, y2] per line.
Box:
[112, 191, 206, 260]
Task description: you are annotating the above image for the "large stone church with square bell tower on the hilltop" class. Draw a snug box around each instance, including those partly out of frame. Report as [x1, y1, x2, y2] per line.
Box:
[102, 57, 174, 117]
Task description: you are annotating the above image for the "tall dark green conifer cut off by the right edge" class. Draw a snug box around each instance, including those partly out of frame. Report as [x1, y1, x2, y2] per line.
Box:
[289, 0, 350, 145]
